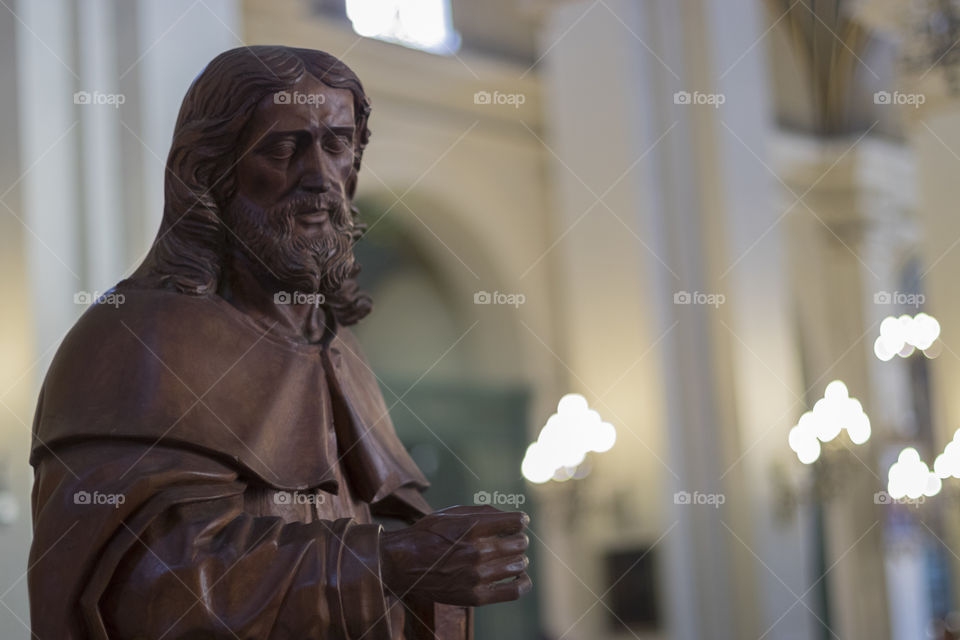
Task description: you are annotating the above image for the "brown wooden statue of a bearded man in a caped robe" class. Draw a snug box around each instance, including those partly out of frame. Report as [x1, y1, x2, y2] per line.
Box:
[29, 46, 530, 640]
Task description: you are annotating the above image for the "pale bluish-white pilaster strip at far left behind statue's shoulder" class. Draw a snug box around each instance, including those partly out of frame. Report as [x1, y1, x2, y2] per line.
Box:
[15, 0, 87, 360]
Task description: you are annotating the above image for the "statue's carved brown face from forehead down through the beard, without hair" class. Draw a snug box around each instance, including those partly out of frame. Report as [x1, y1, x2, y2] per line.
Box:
[224, 75, 356, 294]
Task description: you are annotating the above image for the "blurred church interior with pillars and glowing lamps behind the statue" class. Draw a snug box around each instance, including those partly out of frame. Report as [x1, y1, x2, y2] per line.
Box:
[9, 0, 960, 640]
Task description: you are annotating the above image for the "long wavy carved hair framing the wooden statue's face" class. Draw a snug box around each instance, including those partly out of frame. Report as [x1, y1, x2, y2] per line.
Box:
[119, 46, 372, 324]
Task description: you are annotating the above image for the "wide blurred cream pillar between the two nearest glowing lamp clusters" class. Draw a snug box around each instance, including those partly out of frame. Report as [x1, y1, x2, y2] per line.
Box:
[542, 1, 818, 640]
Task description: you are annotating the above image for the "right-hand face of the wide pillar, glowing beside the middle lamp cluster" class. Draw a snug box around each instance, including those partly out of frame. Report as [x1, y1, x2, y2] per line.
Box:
[692, 0, 825, 638]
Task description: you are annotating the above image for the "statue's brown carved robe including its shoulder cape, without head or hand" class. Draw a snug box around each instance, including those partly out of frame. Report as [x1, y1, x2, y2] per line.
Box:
[28, 287, 471, 640]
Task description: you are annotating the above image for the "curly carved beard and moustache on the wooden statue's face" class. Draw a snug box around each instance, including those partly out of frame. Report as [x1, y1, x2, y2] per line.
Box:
[226, 194, 354, 297]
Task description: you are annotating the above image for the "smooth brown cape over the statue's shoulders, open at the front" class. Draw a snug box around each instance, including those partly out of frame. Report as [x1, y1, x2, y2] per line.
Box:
[30, 289, 429, 515]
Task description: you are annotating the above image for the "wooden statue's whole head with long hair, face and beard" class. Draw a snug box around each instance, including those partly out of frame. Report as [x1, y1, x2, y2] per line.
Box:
[131, 46, 371, 324]
